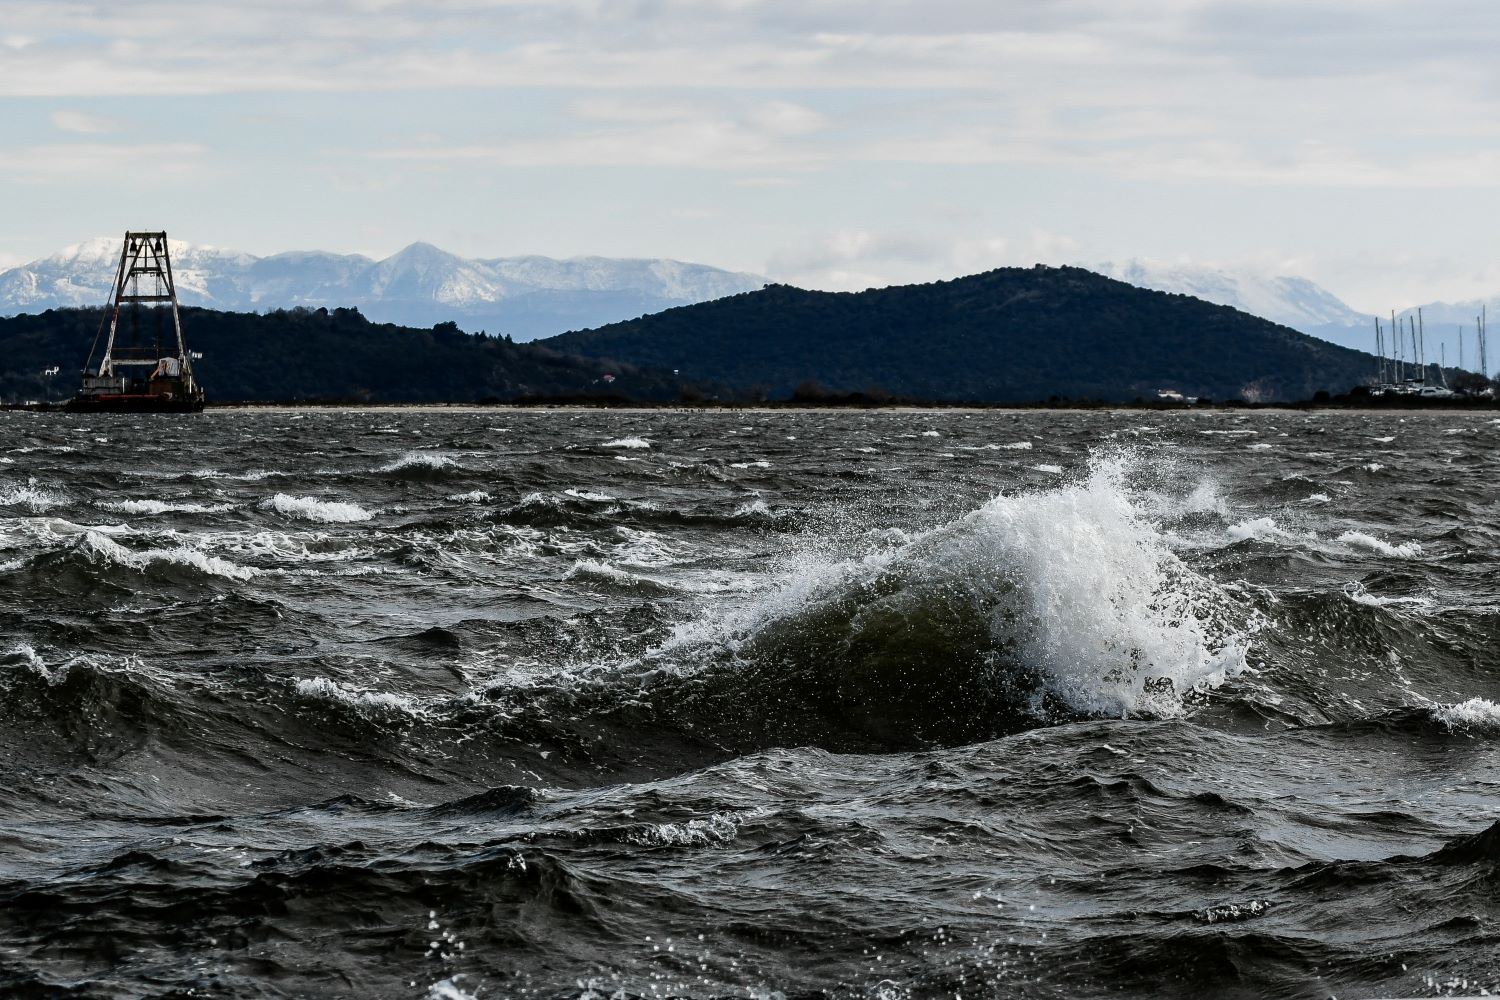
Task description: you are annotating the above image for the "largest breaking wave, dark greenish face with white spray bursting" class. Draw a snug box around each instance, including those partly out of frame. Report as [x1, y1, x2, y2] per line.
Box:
[656, 457, 1253, 743]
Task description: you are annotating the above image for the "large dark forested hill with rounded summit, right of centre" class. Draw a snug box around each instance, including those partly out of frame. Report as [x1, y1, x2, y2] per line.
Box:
[539, 265, 1376, 402]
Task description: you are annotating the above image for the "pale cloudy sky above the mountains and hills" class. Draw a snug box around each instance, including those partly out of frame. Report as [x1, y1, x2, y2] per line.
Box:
[0, 0, 1500, 313]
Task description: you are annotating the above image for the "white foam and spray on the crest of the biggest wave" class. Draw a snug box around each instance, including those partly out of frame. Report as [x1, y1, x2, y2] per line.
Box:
[675, 457, 1253, 715]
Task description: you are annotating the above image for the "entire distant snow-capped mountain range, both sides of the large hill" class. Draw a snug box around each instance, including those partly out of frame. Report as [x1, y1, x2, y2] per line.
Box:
[0, 237, 1500, 369]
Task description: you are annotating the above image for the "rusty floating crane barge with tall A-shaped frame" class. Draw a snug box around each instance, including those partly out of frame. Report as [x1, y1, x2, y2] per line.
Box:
[66, 232, 203, 414]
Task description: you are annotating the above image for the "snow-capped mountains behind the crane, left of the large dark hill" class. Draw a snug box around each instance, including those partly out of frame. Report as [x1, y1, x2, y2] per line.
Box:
[0, 237, 765, 340]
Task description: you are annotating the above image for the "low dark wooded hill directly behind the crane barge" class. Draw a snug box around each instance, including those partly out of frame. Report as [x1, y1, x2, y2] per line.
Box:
[0, 307, 680, 402]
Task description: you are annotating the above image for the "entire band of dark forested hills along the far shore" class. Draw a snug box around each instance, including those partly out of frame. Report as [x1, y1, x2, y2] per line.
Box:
[0, 267, 1484, 406]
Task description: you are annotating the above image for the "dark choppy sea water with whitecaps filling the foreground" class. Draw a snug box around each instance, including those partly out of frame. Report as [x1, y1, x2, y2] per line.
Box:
[0, 409, 1500, 1000]
